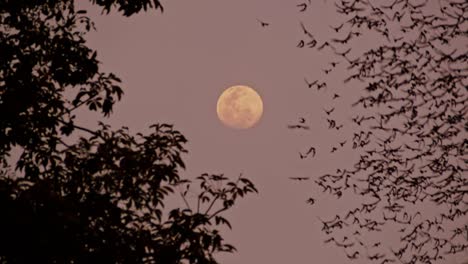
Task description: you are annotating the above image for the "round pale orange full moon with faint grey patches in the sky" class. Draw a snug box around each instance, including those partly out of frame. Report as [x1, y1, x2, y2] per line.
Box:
[216, 85, 263, 129]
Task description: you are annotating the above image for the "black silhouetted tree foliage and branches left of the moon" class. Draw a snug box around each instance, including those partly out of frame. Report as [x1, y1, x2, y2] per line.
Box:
[0, 0, 257, 263]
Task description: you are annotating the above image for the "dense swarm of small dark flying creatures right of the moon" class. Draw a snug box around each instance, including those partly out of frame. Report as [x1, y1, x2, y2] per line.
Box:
[294, 0, 468, 264]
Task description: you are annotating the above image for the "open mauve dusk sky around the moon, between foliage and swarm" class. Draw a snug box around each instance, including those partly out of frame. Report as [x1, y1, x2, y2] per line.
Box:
[77, 0, 462, 264]
